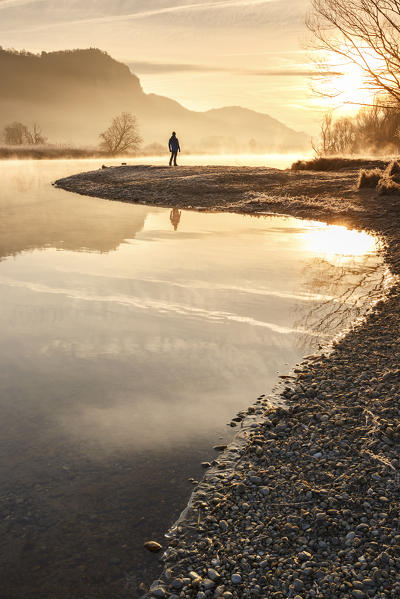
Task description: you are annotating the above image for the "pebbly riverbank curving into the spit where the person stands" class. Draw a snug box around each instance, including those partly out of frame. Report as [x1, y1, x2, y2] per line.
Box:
[57, 165, 400, 599]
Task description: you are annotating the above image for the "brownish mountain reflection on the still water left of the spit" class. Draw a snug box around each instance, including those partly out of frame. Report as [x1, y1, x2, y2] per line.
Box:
[0, 163, 151, 259]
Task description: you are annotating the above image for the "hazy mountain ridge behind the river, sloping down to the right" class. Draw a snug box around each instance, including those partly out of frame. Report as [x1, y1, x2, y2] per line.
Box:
[0, 48, 309, 152]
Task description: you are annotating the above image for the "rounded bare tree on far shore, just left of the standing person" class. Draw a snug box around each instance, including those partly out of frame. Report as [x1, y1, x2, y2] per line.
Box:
[100, 112, 142, 154]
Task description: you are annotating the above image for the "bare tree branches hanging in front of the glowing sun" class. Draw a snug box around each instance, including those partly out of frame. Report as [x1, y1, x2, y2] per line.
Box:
[307, 0, 400, 105]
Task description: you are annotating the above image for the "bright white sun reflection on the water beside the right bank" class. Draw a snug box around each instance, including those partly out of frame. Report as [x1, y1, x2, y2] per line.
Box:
[304, 225, 376, 260]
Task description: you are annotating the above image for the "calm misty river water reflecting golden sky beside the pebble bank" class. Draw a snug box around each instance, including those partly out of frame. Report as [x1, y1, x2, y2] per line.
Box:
[0, 161, 384, 599]
